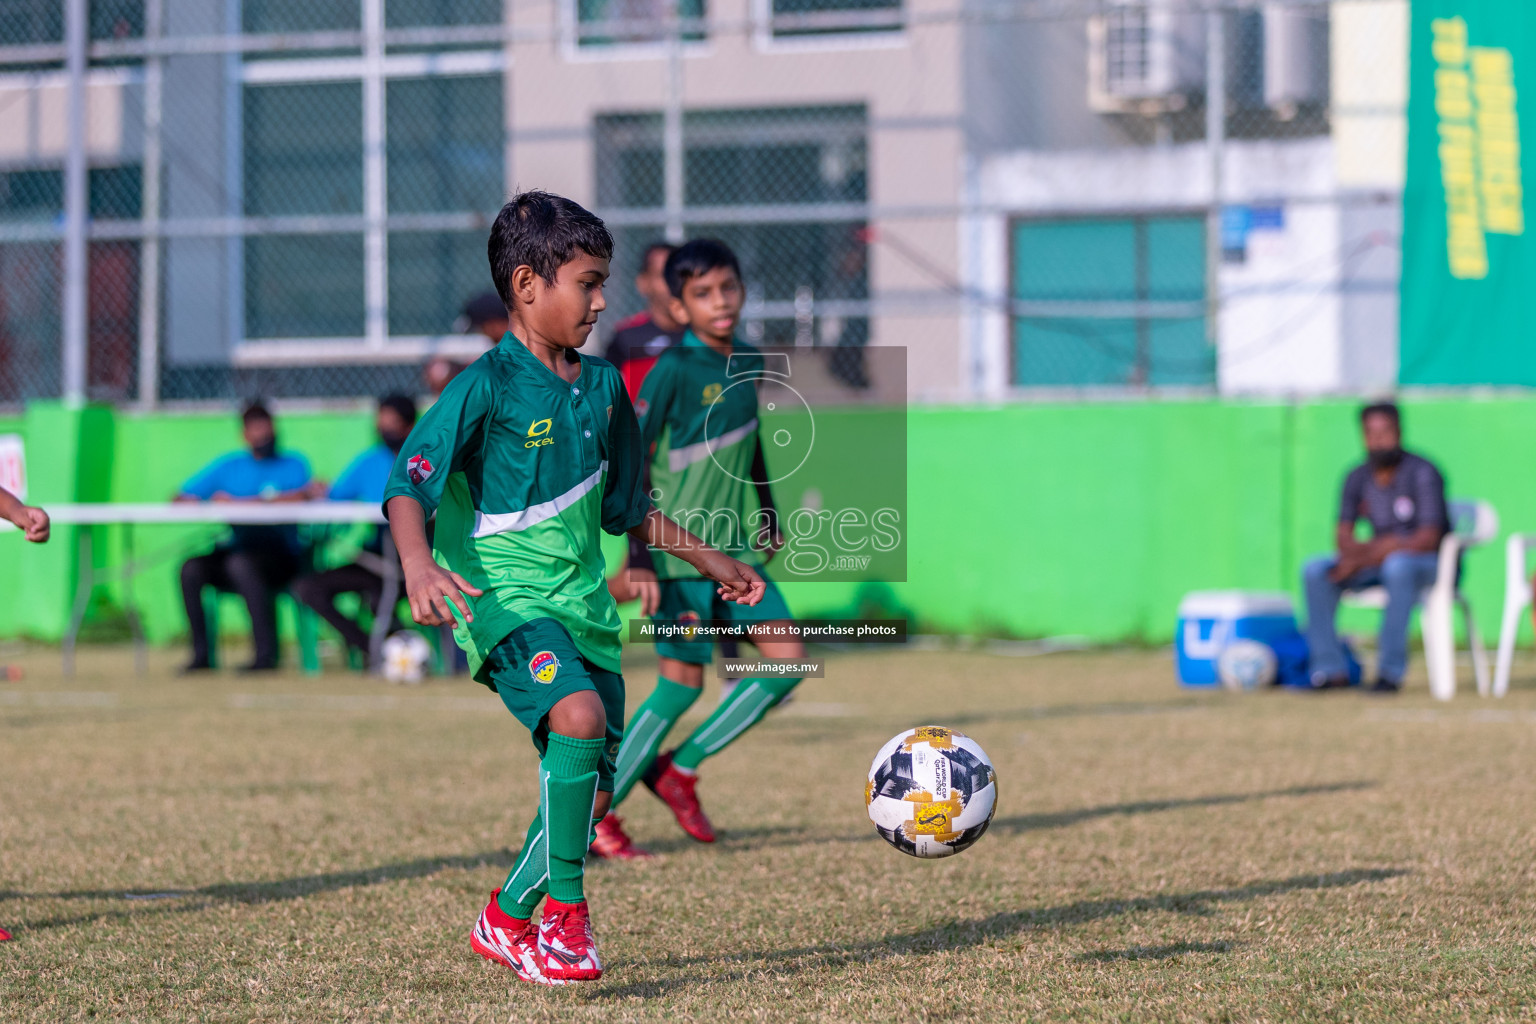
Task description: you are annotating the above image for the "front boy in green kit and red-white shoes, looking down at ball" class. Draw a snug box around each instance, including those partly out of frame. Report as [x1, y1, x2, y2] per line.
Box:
[384, 192, 763, 984]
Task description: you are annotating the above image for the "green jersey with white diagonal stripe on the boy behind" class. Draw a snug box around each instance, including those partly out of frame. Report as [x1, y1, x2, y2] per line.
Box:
[636, 330, 763, 579]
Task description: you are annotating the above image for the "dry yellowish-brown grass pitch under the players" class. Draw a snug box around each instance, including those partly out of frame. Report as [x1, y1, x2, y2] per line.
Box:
[0, 648, 1536, 1024]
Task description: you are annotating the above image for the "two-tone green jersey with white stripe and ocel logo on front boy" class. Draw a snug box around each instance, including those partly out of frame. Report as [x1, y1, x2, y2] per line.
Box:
[384, 333, 651, 685]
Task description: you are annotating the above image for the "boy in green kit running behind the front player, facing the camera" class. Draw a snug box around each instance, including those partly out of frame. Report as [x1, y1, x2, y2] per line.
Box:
[596, 239, 805, 858]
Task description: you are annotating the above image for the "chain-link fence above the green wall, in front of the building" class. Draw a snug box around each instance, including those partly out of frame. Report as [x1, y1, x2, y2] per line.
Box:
[0, 0, 1407, 404]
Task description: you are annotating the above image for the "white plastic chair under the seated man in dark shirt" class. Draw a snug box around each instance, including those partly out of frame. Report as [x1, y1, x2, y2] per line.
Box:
[1344, 502, 1499, 700]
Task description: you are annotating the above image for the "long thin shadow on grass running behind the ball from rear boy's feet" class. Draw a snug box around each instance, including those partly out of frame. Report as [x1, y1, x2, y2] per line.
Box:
[642, 780, 1376, 854]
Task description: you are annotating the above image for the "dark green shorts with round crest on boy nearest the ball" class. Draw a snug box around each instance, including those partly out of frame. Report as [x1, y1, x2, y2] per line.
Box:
[485, 619, 624, 792]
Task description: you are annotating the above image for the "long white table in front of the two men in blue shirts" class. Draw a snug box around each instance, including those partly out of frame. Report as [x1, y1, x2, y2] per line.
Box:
[46, 500, 401, 674]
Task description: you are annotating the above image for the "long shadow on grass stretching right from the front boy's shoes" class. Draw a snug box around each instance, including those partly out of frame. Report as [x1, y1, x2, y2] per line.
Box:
[591, 867, 1409, 999]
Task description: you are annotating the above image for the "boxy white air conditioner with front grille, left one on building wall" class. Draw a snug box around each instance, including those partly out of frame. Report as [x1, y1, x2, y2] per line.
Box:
[1087, 0, 1206, 114]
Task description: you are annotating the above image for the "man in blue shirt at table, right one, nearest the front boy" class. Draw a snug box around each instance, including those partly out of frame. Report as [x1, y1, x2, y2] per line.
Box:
[293, 395, 416, 668]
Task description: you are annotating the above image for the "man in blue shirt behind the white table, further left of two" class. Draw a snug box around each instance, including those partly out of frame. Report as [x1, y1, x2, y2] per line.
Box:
[175, 402, 312, 672]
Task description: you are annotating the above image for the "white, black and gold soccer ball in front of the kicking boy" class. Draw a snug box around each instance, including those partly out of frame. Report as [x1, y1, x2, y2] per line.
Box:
[865, 725, 997, 858]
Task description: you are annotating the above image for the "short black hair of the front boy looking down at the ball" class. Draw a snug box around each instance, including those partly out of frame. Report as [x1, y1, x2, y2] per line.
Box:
[485, 189, 613, 303]
